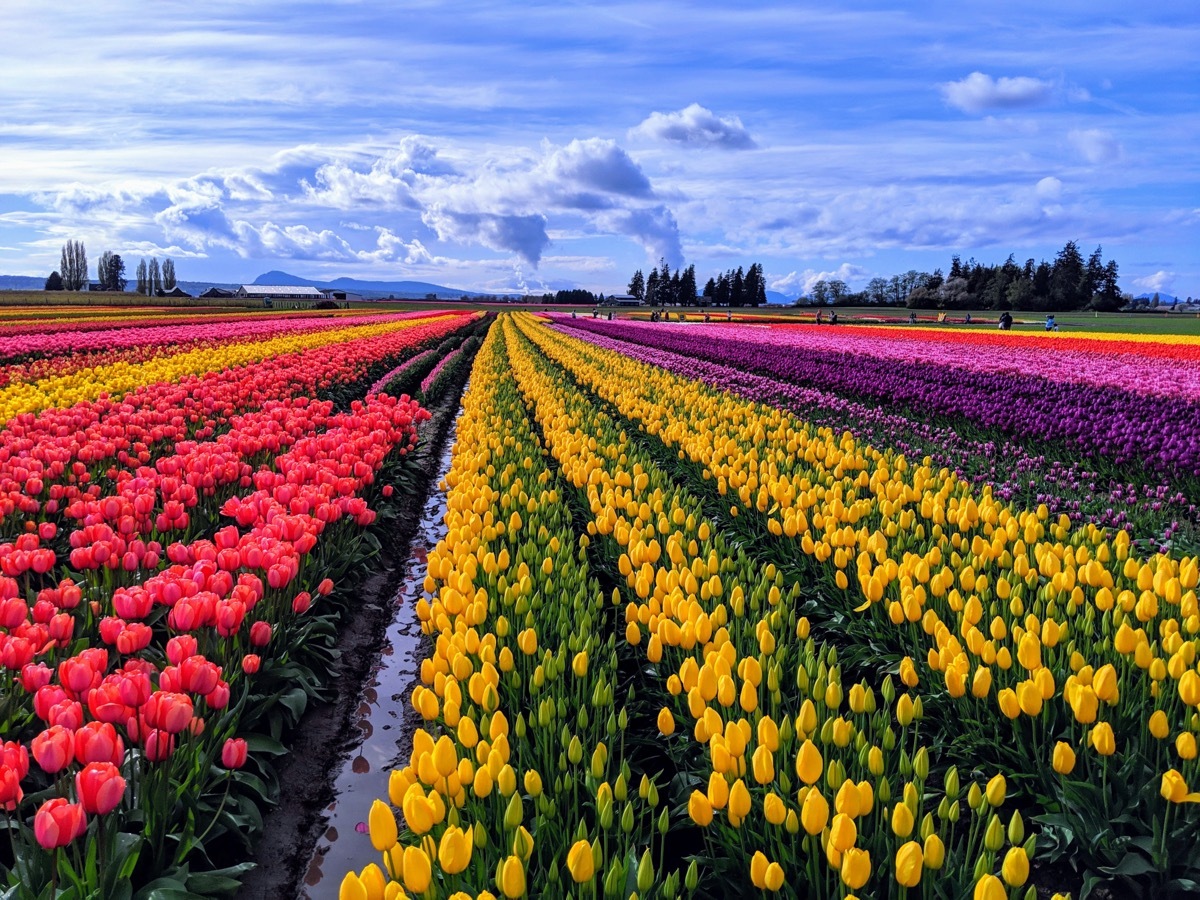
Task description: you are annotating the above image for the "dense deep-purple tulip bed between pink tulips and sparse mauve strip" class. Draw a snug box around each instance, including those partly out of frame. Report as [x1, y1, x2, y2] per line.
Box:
[559, 319, 1200, 487]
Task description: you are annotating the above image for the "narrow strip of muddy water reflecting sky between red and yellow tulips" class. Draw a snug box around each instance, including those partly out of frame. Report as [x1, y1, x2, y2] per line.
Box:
[301, 416, 457, 900]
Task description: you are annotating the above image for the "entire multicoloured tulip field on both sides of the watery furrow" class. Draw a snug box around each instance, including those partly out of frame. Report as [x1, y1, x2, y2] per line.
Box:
[0, 307, 1200, 900]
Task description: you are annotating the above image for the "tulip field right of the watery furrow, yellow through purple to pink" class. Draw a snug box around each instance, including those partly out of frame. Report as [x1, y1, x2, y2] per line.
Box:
[340, 313, 1200, 900]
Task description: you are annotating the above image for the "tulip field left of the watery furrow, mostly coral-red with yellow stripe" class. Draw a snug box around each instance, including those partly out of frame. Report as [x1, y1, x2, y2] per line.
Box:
[0, 307, 481, 900]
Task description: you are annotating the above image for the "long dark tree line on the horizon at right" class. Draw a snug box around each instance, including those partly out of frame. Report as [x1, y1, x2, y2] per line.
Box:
[798, 241, 1132, 312]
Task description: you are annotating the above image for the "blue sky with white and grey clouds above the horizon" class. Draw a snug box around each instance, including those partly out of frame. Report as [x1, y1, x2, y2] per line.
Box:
[0, 0, 1200, 296]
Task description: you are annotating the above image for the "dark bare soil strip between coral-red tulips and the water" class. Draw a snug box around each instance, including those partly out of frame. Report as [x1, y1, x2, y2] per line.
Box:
[236, 391, 461, 900]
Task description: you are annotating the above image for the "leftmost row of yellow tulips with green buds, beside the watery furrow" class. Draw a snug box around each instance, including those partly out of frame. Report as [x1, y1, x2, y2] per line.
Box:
[341, 329, 680, 900]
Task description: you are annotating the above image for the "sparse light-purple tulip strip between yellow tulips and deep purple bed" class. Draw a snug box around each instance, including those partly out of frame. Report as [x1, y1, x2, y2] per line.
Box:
[557, 319, 1196, 539]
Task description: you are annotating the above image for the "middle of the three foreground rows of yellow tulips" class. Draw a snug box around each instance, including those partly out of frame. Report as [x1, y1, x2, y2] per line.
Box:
[503, 317, 1033, 898]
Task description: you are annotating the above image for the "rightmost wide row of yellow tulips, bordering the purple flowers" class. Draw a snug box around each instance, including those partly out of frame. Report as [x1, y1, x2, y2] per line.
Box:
[523, 314, 1200, 877]
